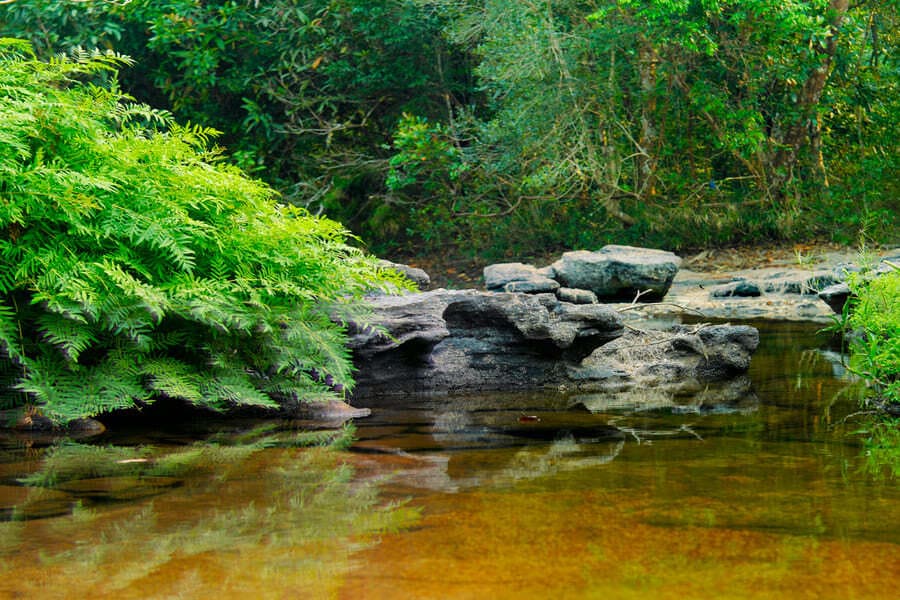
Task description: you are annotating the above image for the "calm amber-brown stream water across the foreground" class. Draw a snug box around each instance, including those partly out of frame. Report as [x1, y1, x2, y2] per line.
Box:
[0, 325, 900, 599]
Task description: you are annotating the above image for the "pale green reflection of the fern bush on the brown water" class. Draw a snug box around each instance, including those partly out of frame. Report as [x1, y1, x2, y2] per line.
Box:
[0, 436, 418, 598]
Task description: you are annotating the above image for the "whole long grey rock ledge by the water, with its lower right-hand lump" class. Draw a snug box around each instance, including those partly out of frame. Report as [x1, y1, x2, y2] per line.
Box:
[350, 290, 758, 405]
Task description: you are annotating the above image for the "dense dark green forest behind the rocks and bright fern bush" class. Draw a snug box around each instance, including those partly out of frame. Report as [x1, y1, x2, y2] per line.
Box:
[0, 0, 900, 259]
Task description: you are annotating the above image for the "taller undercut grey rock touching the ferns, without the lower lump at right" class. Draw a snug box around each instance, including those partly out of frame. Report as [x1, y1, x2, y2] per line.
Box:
[349, 290, 624, 398]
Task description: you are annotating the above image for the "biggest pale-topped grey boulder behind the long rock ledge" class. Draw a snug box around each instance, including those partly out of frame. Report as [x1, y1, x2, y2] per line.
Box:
[552, 245, 681, 302]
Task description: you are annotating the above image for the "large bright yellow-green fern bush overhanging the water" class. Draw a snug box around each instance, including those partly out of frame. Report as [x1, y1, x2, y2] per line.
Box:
[0, 40, 406, 421]
